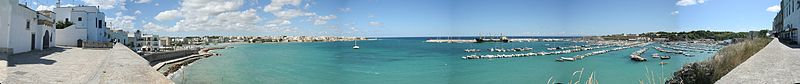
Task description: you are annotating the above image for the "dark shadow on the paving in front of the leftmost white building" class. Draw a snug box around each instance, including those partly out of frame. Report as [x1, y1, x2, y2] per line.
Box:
[8, 47, 71, 67]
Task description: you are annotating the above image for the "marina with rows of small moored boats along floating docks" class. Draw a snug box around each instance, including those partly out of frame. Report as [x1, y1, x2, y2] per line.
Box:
[461, 41, 721, 64]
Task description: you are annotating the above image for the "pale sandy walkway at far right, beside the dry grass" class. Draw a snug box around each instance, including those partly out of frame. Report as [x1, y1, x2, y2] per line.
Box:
[716, 39, 800, 84]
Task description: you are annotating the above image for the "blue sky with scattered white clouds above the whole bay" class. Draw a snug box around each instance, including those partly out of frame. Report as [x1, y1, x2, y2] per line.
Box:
[20, 0, 780, 37]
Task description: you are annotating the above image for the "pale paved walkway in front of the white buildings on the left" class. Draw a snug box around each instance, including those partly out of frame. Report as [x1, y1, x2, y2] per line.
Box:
[4, 44, 173, 84]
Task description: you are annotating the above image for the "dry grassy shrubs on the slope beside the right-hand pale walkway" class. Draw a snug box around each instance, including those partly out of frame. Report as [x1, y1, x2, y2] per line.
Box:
[708, 38, 772, 81]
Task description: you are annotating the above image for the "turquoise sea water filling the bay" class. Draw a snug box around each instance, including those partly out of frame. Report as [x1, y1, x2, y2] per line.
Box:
[172, 38, 713, 84]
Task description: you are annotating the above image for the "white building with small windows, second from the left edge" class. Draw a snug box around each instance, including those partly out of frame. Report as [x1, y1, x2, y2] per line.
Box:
[53, 6, 111, 46]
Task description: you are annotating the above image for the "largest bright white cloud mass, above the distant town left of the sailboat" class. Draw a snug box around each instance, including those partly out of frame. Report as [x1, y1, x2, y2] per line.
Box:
[142, 0, 337, 33]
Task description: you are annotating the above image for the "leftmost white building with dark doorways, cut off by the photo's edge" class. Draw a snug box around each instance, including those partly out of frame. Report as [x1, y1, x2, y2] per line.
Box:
[0, 0, 55, 54]
